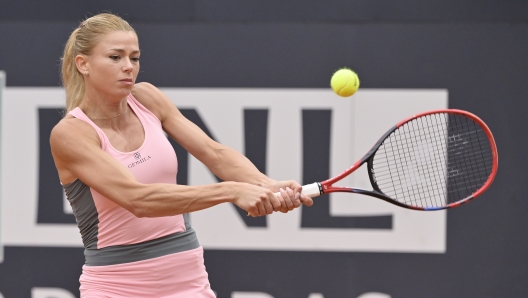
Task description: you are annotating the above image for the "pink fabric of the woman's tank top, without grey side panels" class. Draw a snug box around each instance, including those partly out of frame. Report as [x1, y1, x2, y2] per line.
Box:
[69, 95, 186, 249]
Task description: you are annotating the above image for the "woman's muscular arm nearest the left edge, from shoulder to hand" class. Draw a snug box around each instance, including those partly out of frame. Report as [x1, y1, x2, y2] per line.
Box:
[50, 118, 280, 217]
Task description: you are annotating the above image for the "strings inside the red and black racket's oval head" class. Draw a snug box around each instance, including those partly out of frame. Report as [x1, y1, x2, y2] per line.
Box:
[372, 113, 493, 207]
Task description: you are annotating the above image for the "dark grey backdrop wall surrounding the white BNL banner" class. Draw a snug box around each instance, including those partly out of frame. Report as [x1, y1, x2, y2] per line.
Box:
[0, 0, 528, 298]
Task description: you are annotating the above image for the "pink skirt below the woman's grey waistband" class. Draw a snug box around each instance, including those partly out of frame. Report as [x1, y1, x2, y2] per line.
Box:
[79, 247, 215, 298]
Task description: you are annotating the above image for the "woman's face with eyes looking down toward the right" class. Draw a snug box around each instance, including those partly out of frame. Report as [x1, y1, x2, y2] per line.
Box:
[80, 31, 140, 99]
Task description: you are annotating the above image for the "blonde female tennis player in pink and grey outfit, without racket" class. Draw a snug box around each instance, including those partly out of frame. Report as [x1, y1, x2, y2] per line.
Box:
[50, 13, 312, 298]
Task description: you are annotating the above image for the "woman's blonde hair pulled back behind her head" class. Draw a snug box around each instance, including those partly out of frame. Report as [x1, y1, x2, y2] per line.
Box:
[61, 13, 137, 113]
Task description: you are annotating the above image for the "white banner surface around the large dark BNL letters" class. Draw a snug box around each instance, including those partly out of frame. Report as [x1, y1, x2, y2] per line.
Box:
[0, 87, 448, 253]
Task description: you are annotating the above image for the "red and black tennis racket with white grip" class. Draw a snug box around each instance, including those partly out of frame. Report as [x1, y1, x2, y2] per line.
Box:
[302, 109, 498, 210]
